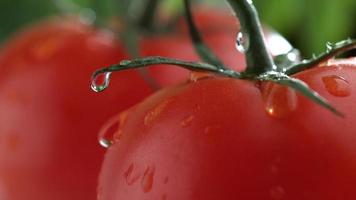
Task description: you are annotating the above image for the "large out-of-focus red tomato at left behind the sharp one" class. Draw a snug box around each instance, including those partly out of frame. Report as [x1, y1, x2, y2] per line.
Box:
[0, 18, 152, 200]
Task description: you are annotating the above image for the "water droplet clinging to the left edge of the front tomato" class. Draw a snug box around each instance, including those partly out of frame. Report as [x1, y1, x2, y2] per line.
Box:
[98, 110, 129, 148]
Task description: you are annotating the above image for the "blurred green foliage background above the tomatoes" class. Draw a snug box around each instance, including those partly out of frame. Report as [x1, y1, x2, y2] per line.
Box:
[0, 0, 356, 57]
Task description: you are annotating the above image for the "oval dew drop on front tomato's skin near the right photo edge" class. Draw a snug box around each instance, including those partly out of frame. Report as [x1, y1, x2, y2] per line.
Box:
[322, 75, 351, 97]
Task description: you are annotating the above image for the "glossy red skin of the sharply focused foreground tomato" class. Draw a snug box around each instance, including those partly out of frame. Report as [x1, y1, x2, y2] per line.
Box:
[98, 61, 356, 200]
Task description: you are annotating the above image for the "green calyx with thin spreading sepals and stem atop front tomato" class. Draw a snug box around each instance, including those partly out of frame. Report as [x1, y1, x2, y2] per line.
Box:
[92, 0, 356, 116]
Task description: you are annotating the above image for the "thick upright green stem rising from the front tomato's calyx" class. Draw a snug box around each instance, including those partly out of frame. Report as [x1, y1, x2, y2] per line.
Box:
[227, 0, 275, 75]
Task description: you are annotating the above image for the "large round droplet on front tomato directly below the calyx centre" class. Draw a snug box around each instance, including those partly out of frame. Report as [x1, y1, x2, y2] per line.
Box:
[262, 83, 297, 118]
